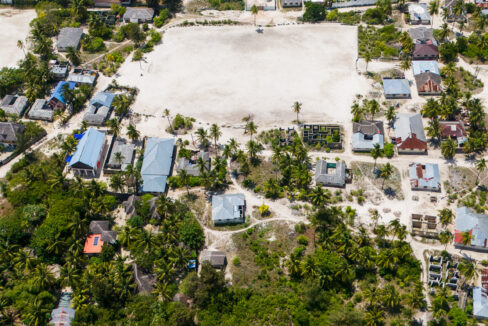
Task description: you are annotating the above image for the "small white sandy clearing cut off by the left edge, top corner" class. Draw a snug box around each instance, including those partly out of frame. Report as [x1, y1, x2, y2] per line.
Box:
[0, 8, 36, 67]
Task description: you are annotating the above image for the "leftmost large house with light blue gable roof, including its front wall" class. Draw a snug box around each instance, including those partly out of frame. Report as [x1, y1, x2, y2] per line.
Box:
[68, 128, 105, 177]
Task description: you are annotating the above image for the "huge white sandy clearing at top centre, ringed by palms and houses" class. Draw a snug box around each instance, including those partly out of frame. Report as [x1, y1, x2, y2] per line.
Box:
[118, 24, 370, 127]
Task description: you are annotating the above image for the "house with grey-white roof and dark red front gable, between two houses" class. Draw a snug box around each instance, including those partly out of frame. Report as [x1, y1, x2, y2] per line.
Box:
[393, 114, 427, 154]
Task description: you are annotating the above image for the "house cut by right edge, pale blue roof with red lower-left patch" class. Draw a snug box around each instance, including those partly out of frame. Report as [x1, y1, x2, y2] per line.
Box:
[454, 206, 488, 252]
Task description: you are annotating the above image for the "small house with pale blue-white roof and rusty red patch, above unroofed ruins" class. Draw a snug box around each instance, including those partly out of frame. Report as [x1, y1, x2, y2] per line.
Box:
[408, 163, 441, 191]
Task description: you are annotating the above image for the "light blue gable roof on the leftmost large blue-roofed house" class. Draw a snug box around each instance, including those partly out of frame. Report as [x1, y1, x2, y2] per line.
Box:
[68, 128, 105, 169]
